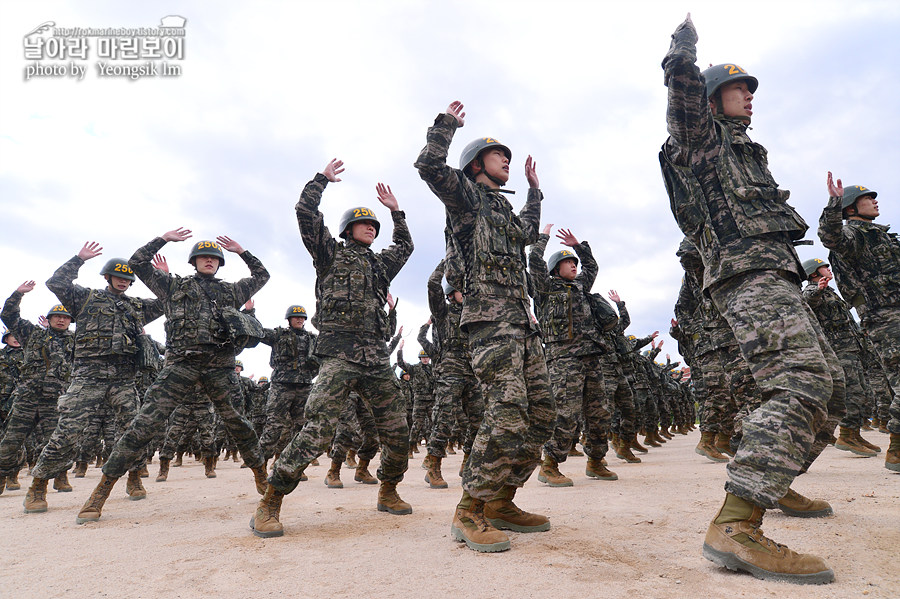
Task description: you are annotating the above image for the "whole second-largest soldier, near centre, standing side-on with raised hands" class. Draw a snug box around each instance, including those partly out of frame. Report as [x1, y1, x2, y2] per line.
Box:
[416, 102, 556, 552]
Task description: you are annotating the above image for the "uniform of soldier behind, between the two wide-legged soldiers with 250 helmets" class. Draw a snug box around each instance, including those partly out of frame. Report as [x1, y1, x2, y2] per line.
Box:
[259, 327, 319, 460]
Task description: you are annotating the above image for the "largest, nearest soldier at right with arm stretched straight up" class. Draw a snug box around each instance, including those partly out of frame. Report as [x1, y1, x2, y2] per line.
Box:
[660, 15, 844, 583]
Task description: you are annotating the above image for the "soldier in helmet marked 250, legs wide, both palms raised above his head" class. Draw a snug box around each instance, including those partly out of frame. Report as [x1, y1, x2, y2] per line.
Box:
[250, 159, 413, 537]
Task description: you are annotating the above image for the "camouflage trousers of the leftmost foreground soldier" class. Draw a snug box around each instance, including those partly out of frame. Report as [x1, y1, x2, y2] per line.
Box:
[0, 380, 65, 476]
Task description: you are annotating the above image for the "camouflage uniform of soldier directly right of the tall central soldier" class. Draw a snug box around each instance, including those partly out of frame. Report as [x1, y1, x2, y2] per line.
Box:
[528, 233, 610, 464]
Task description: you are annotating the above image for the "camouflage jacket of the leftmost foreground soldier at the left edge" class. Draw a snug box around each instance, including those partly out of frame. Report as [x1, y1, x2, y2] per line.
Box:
[0, 291, 75, 385]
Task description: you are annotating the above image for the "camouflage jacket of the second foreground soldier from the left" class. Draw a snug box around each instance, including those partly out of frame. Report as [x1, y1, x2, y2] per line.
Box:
[47, 256, 163, 378]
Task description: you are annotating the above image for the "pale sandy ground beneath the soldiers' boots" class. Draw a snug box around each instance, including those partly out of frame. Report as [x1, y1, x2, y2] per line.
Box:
[0, 431, 900, 599]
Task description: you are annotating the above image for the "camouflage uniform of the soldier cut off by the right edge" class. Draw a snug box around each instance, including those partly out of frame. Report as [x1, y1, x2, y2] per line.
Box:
[819, 198, 900, 434]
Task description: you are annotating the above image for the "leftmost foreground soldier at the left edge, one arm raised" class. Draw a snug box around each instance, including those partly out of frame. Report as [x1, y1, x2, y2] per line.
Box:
[0, 288, 75, 502]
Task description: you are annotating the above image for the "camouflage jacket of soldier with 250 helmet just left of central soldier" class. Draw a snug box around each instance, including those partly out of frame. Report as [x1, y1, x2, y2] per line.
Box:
[296, 173, 413, 366]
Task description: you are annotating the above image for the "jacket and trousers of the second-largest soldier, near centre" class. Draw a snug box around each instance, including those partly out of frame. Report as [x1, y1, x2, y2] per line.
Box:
[416, 114, 556, 501]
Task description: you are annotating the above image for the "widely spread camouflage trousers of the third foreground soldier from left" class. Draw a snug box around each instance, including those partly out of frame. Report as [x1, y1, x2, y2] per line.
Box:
[103, 355, 264, 478]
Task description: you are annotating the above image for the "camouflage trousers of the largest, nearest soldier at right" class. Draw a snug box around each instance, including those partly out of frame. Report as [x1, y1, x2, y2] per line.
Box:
[711, 271, 844, 508]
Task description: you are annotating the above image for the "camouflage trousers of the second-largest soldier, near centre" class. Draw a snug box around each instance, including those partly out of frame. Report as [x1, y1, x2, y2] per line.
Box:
[462, 322, 556, 501]
